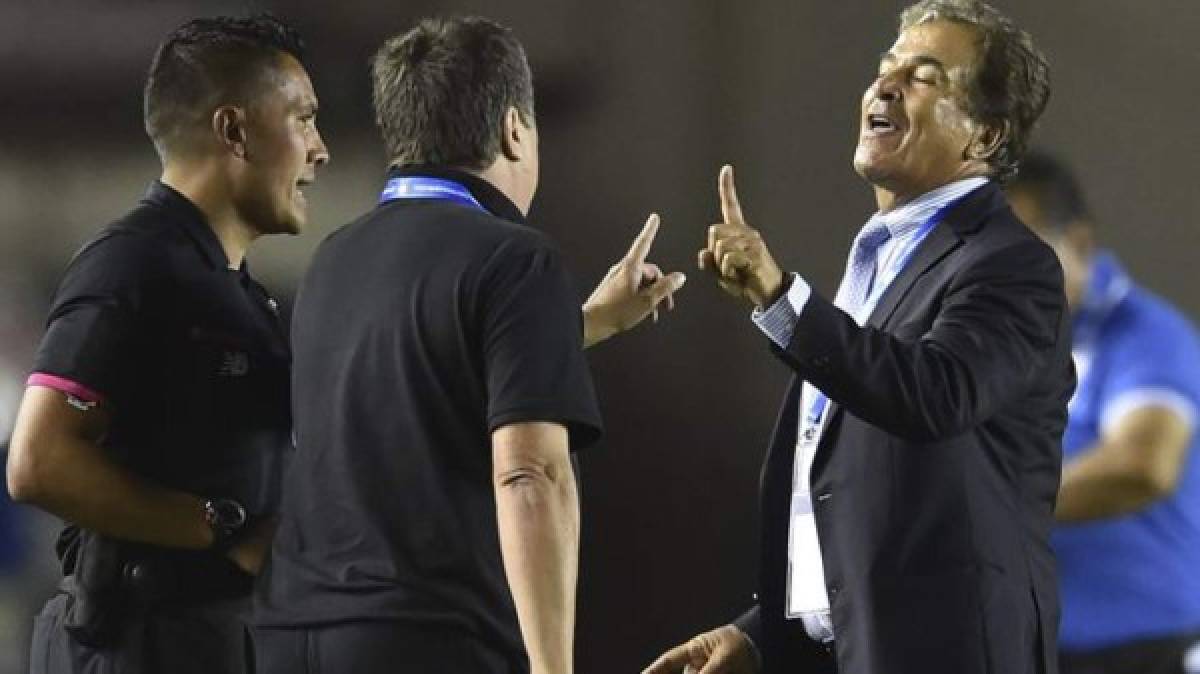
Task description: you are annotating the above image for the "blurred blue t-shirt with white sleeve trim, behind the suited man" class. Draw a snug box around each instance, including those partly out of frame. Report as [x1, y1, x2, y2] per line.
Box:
[1052, 253, 1200, 650]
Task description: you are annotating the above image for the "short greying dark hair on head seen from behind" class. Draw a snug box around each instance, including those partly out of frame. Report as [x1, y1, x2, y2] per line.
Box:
[371, 17, 534, 170]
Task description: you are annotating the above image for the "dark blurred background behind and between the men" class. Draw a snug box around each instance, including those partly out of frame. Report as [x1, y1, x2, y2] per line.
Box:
[0, 0, 1200, 674]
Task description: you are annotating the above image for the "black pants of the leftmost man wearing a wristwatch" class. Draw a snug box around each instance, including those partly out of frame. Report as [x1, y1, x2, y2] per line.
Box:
[29, 582, 253, 674]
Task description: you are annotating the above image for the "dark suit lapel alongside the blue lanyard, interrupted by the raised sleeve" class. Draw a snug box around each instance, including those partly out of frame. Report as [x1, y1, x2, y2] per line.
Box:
[812, 182, 1008, 460]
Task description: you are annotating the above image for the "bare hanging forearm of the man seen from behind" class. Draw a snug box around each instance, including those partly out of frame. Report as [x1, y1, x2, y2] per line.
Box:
[496, 465, 580, 674]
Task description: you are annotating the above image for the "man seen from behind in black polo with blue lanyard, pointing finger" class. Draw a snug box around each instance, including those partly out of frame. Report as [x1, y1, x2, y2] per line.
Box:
[256, 14, 683, 674]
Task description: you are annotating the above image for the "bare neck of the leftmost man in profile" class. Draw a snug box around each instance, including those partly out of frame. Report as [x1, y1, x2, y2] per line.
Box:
[160, 162, 259, 269]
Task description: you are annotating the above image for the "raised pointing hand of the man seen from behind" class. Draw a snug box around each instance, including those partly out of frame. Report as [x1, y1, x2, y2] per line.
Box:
[583, 215, 686, 348]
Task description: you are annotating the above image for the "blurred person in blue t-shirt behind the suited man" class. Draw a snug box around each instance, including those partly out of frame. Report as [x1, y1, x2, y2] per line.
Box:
[1008, 154, 1200, 674]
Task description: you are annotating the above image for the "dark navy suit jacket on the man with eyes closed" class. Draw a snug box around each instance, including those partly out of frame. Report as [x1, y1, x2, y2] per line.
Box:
[737, 183, 1075, 674]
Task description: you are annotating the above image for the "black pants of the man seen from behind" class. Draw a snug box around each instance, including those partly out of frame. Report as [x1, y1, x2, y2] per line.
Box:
[254, 621, 529, 674]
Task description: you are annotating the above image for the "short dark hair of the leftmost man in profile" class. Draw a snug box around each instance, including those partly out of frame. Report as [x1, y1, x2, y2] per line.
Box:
[143, 14, 304, 157]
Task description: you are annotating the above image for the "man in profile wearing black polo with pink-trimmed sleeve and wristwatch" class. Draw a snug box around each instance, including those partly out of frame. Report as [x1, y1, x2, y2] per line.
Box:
[8, 17, 328, 674]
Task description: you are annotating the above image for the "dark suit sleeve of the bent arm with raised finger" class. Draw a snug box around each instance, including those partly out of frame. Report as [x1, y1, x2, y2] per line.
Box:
[778, 239, 1066, 441]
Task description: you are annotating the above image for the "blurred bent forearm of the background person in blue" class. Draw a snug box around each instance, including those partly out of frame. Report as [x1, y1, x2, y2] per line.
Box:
[1055, 450, 1165, 523]
